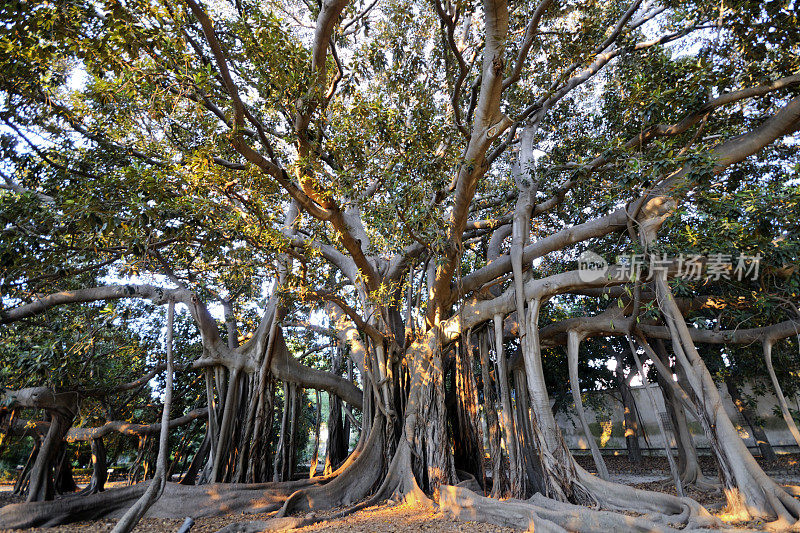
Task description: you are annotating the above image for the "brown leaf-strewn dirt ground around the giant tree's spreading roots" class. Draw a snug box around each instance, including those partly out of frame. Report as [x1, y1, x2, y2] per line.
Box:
[0, 454, 800, 533]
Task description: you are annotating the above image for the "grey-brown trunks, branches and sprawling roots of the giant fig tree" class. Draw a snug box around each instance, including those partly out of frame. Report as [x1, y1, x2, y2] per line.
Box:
[0, 0, 800, 532]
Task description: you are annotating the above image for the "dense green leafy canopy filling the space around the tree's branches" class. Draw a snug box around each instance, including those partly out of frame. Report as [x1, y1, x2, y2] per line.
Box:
[0, 0, 800, 478]
